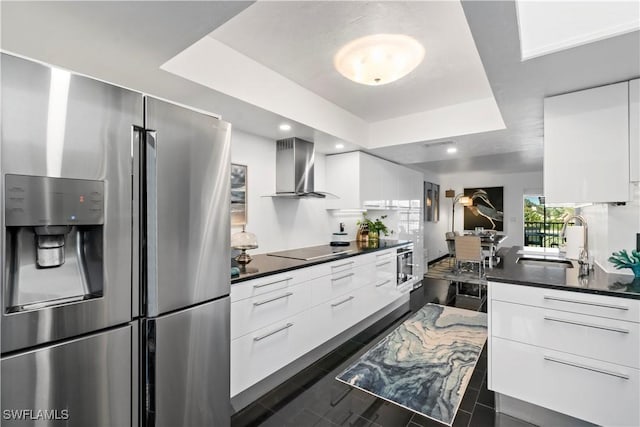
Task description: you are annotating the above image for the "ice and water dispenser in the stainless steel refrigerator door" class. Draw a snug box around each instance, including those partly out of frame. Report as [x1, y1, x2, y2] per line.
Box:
[4, 174, 104, 313]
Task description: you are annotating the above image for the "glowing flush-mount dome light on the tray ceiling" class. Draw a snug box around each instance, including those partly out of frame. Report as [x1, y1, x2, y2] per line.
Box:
[333, 34, 424, 86]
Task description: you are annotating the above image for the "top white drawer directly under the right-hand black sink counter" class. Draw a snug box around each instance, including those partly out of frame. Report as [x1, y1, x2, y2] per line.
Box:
[489, 282, 640, 323]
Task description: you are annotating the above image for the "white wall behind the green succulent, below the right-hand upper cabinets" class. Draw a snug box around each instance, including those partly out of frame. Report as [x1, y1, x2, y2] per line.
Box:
[580, 183, 640, 275]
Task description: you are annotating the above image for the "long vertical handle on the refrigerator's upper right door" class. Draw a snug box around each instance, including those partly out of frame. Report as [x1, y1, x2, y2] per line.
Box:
[145, 130, 159, 317]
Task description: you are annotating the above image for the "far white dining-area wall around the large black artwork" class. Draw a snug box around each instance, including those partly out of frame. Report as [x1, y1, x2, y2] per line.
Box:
[425, 172, 542, 260]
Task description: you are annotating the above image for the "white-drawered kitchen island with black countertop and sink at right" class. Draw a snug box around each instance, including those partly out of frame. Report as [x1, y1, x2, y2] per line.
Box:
[487, 247, 640, 426]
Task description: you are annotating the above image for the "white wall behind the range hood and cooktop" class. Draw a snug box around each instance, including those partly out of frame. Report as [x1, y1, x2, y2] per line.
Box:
[231, 130, 332, 254]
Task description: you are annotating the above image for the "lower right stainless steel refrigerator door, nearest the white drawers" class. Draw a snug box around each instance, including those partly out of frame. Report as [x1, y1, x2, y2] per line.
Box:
[144, 297, 231, 427]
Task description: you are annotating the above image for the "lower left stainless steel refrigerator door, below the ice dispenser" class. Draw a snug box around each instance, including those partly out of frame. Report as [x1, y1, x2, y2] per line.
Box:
[1, 326, 132, 427]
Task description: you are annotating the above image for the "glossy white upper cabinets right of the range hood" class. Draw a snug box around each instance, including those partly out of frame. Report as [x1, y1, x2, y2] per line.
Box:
[326, 151, 423, 209]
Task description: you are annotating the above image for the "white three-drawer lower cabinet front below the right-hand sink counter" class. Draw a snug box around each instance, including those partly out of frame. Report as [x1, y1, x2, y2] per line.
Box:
[488, 282, 640, 426]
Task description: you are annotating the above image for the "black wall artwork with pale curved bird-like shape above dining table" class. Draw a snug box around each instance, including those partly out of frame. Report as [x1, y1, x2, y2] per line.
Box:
[464, 187, 504, 231]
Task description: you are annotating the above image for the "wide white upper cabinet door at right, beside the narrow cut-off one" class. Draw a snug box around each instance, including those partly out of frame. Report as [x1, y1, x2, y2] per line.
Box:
[544, 82, 630, 203]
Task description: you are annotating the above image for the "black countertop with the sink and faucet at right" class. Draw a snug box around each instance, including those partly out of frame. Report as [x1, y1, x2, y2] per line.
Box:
[486, 246, 640, 299]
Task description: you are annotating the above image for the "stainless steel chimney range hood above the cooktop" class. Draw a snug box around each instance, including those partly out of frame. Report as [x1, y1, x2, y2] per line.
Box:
[270, 137, 337, 198]
